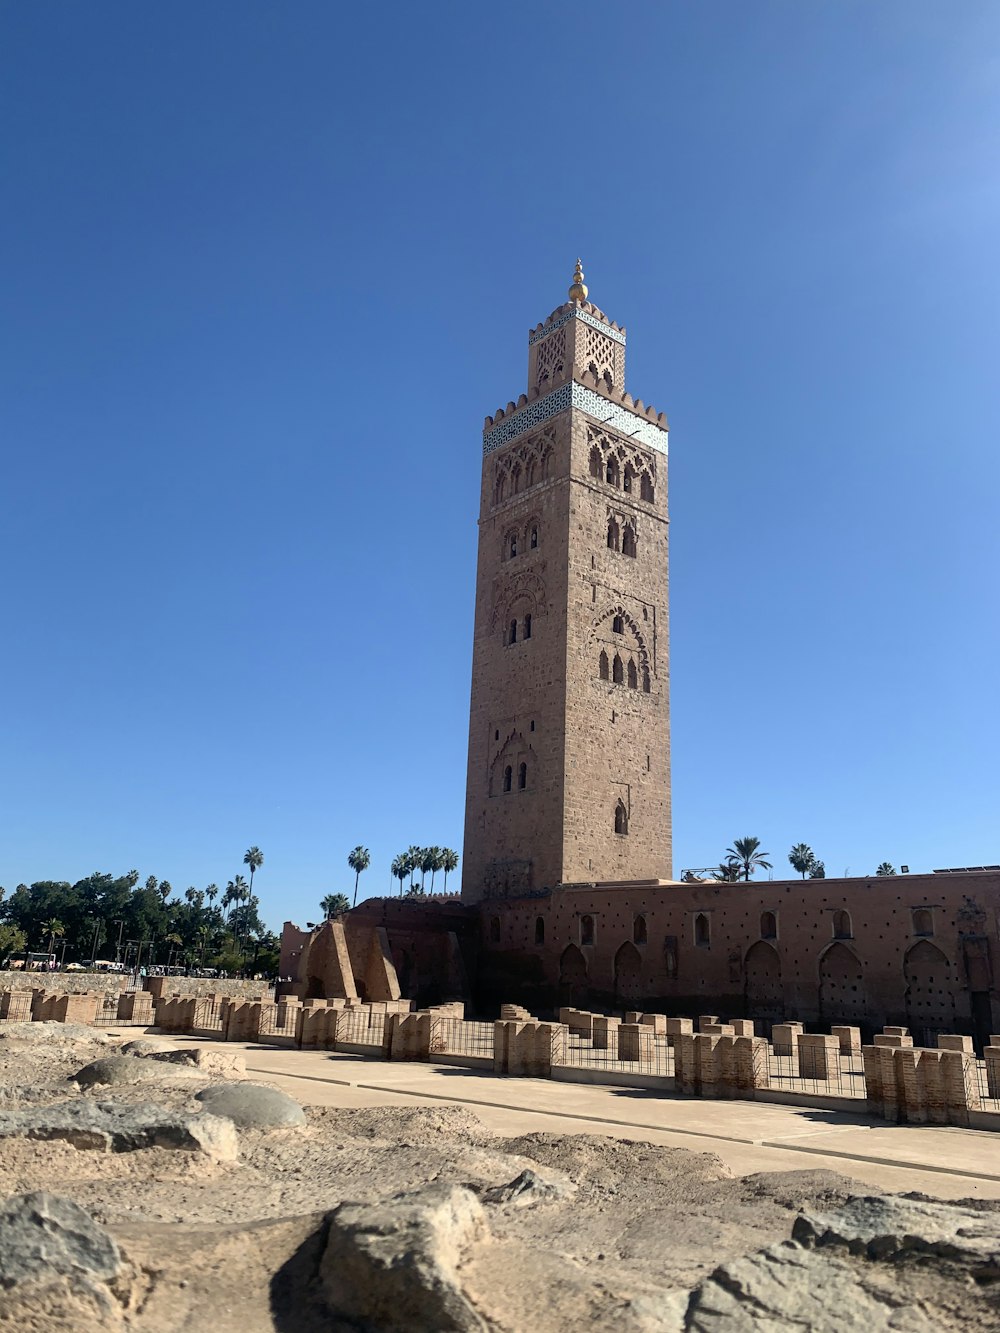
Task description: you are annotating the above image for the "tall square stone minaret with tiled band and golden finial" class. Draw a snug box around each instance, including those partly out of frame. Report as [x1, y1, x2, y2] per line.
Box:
[461, 260, 671, 901]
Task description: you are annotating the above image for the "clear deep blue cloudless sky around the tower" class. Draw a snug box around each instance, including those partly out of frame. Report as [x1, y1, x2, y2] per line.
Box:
[0, 0, 1000, 925]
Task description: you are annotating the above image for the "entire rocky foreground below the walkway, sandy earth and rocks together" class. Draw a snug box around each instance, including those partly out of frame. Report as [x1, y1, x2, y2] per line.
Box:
[0, 1024, 1000, 1333]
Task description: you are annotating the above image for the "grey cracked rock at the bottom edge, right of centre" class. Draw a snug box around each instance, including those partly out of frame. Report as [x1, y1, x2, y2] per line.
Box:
[684, 1241, 940, 1333]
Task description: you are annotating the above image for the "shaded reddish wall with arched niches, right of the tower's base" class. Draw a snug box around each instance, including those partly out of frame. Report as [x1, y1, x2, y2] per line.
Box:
[476, 872, 1000, 1040]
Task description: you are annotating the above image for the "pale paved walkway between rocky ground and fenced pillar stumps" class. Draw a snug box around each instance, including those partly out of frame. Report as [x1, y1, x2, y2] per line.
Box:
[200, 1038, 1000, 1198]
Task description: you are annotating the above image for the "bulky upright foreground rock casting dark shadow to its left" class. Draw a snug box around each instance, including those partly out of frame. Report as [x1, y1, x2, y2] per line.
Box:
[320, 1185, 488, 1333]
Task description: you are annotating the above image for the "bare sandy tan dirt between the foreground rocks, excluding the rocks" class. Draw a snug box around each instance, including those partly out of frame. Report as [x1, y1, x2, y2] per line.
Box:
[0, 1025, 1000, 1333]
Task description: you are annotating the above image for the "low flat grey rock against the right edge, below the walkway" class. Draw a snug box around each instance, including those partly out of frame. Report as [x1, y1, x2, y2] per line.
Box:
[792, 1194, 1000, 1281]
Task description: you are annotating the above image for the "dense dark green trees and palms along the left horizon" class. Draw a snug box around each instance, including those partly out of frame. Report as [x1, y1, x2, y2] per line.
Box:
[0, 846, 279, 973]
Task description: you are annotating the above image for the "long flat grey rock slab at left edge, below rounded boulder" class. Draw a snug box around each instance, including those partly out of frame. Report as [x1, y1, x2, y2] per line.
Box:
[0, 1098, 240, 1161]
